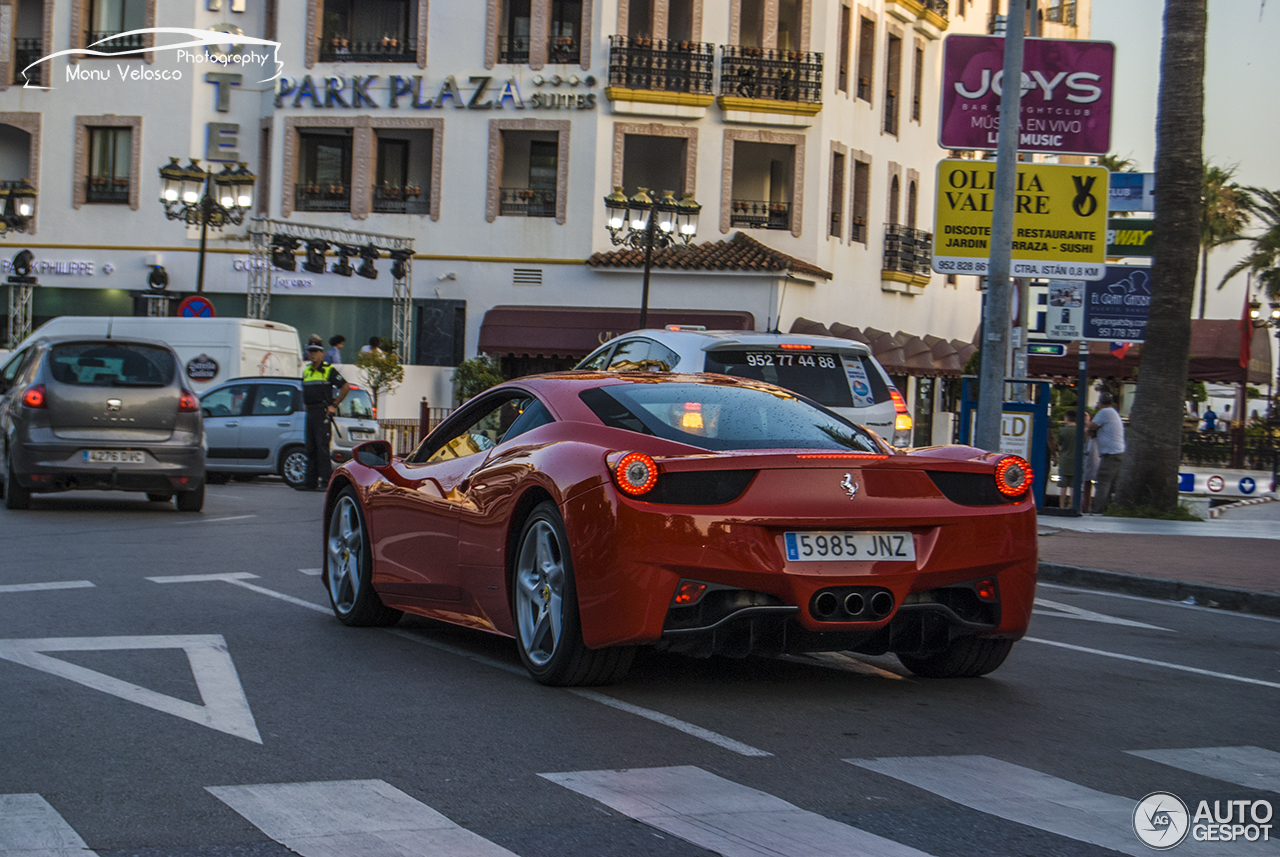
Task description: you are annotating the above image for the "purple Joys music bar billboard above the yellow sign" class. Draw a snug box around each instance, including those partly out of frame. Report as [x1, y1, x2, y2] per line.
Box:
[938, 35, 1115, 155]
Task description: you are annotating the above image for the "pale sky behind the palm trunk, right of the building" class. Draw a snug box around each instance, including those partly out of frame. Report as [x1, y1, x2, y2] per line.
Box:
[1089, 0, 1280, 318]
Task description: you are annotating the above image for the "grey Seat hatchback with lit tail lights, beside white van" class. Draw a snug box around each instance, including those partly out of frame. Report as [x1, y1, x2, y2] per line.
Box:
[0, 336, 205, 512]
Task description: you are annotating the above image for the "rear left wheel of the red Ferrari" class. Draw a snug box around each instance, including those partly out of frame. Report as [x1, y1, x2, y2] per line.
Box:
[511, 501, 635, 687]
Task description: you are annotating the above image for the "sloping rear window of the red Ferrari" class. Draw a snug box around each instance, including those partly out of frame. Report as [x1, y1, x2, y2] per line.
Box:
[580, 382, 884, 453]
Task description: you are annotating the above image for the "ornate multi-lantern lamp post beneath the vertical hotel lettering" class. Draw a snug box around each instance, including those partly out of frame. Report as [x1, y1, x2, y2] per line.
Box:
[160, 157, 257, 292]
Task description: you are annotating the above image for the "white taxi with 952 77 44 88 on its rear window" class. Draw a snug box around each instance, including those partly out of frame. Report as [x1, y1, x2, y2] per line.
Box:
[577, 325, 911, 446]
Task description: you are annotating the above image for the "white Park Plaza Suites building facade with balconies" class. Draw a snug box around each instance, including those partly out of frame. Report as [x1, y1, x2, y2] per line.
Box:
[0, 0, 1088, 427]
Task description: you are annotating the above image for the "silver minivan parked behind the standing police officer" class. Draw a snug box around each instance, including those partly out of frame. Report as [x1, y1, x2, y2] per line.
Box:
[200, 377, 381, 487]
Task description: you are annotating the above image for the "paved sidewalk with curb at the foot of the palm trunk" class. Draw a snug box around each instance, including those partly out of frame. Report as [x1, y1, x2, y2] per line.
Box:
[1039, 501, 1280, 617]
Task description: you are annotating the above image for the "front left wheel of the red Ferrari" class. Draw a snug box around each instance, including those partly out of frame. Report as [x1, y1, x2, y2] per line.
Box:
[320, 487, 404, 627]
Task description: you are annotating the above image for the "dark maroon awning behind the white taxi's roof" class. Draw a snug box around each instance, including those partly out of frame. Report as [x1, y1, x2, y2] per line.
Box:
[479, 306, 755, 357]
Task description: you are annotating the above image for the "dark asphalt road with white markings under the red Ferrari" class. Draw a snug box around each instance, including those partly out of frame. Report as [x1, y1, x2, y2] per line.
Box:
[0, 482, 1280, 857]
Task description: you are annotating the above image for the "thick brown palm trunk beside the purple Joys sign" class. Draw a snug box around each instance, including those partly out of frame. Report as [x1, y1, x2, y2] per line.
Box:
[1115, 0, 1208, 512]
